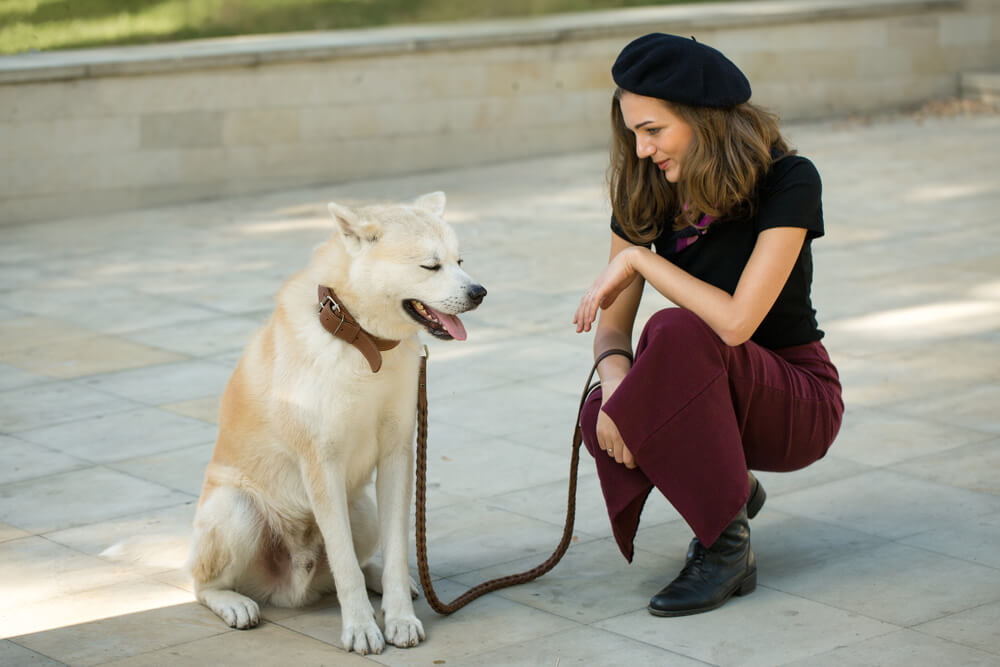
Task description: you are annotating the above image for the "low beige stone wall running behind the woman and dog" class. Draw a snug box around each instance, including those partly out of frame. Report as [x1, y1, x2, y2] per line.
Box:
[0, 0, 1000, 224]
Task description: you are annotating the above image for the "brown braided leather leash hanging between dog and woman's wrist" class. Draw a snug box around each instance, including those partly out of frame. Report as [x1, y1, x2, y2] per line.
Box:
[416, 348, 632, 614]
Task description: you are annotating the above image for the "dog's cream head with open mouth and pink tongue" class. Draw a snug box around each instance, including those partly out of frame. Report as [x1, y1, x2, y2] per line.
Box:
[329, 192, 486, 340]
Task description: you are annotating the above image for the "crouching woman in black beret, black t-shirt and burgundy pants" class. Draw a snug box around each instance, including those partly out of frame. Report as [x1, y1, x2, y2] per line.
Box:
[574, 33, 843, 616]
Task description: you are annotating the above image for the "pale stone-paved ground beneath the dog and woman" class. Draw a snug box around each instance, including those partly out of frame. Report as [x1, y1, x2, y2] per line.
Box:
[0, 107, 1000, 666]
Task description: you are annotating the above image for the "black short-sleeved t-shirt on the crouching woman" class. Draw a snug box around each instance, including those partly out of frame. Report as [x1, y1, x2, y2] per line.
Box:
[611, 155, 824, 350]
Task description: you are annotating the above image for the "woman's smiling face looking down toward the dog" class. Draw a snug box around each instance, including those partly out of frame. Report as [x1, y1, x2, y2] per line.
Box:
[619, 92, 694, 183]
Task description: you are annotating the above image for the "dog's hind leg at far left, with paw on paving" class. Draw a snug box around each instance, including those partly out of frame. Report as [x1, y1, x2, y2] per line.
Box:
[187, 487, 264, 630]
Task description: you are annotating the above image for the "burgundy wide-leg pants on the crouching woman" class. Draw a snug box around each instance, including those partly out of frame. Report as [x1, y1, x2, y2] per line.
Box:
[580, 308, 844, 562]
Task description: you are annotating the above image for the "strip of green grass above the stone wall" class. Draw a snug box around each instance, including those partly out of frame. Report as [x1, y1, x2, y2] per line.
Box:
[0, 0, 711, 53]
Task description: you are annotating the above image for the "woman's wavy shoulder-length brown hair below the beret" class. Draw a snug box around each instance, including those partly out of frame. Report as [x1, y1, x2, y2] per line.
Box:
[608, 88, 789, 243]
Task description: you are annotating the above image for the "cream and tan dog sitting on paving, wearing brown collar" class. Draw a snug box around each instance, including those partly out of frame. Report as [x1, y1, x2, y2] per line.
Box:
[187, 192, 486, 654]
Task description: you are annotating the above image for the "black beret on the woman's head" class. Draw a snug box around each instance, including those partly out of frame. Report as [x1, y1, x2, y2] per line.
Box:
[611, 32, 750, 107]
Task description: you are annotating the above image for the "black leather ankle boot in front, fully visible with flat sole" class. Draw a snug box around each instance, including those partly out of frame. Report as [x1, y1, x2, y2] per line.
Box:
[649, 509, 757, 616]
